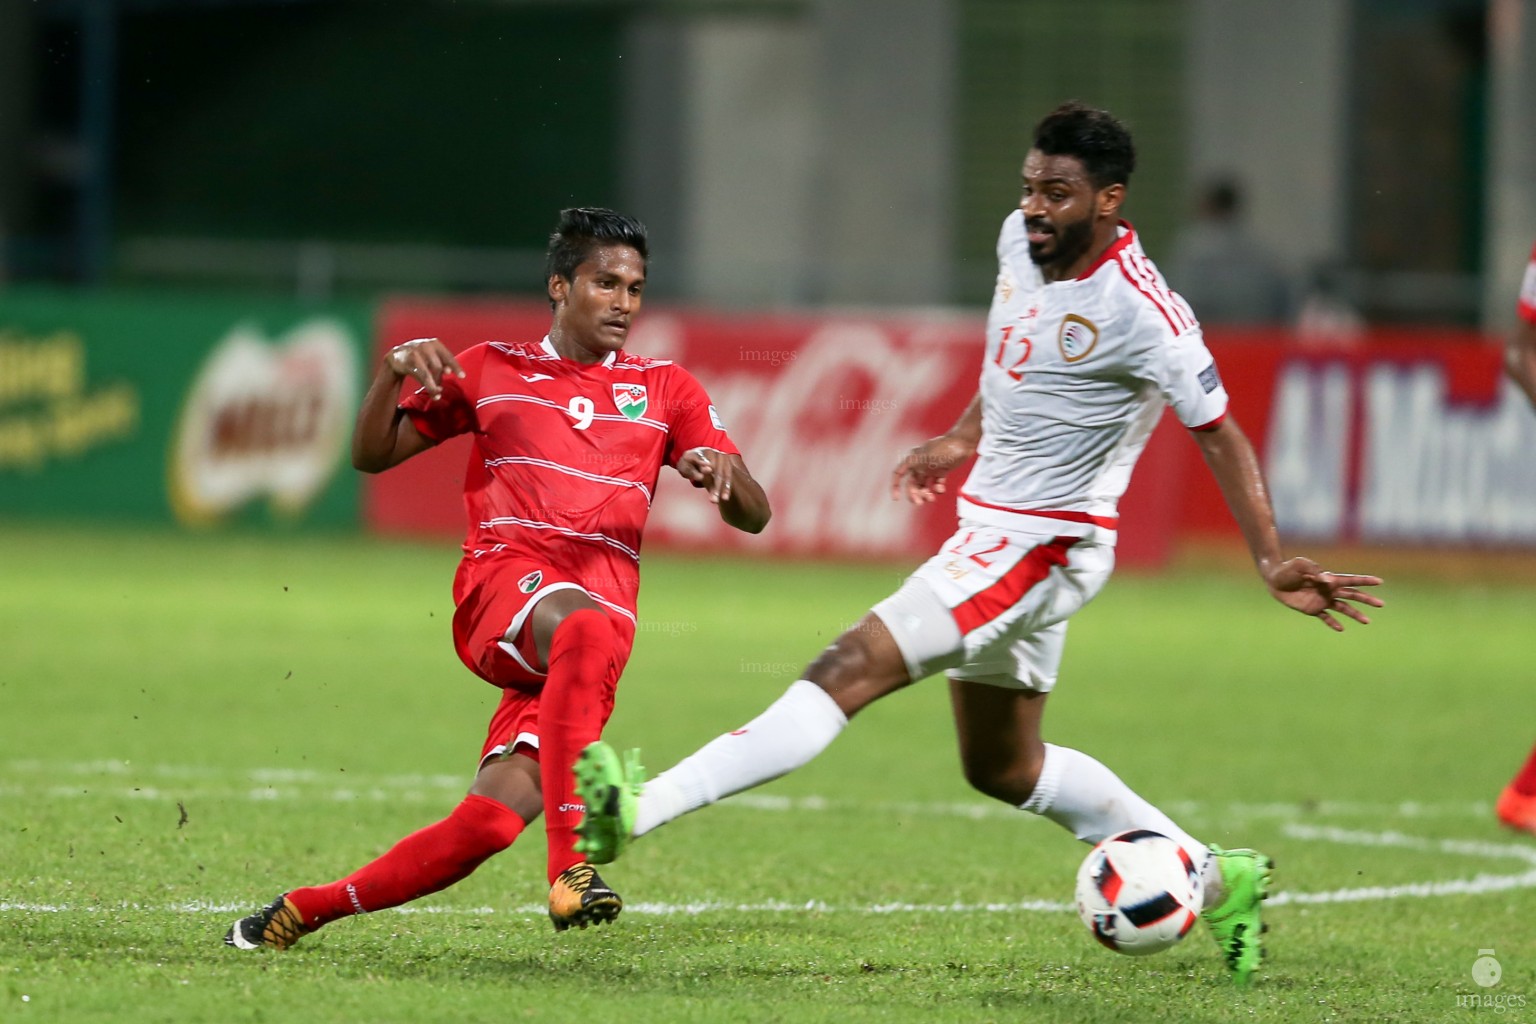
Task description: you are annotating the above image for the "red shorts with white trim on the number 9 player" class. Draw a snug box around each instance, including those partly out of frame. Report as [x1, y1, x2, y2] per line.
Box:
[453, 553, 634, 763]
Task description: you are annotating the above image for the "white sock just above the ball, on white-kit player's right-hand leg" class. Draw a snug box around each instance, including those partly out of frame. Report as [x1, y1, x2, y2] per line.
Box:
[1021, 743, 1210, 864]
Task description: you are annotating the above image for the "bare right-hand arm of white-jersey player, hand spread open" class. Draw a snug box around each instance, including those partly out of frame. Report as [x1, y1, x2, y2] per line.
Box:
[1193, 416, 1381, 631]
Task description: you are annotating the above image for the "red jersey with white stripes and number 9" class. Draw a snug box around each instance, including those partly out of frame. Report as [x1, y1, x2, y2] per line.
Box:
[399, 338, 739, 614]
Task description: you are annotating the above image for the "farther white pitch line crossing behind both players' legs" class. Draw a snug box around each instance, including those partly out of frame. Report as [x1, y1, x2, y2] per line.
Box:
[0, 760, 1493, 823]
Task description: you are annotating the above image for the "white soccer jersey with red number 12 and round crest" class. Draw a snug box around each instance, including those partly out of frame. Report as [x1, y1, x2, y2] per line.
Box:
[958, 210, 1227, 542]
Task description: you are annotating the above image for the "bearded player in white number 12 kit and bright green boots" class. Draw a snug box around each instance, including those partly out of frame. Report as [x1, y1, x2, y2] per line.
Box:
[576, 104, 1381, 984]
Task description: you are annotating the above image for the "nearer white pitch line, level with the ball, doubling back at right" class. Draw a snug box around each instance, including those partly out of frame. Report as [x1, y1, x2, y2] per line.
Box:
[0, 824, 1536, 917]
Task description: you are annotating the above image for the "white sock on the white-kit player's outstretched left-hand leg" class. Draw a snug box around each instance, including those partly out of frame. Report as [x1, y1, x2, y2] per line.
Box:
[634, 679, 854, 835]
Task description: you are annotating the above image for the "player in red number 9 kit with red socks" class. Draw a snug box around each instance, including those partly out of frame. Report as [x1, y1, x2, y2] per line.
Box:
[224, 209, 770, 949]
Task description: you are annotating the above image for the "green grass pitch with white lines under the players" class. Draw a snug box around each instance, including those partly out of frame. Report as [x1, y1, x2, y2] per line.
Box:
[0, 524, 1536, 1024]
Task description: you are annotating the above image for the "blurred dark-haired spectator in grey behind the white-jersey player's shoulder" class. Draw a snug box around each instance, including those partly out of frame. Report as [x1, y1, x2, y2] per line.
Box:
[1167, 178, 1290, 324]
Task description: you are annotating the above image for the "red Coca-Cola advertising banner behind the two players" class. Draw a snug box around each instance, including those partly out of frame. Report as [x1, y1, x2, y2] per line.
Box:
[364, 299, 1187, 563]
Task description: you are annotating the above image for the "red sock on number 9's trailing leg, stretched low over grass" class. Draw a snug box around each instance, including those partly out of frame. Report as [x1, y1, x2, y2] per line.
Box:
[287, 795, 524, 929]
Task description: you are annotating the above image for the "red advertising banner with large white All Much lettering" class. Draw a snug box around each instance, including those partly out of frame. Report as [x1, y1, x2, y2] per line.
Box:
[1180, 332, 1536, 548]
